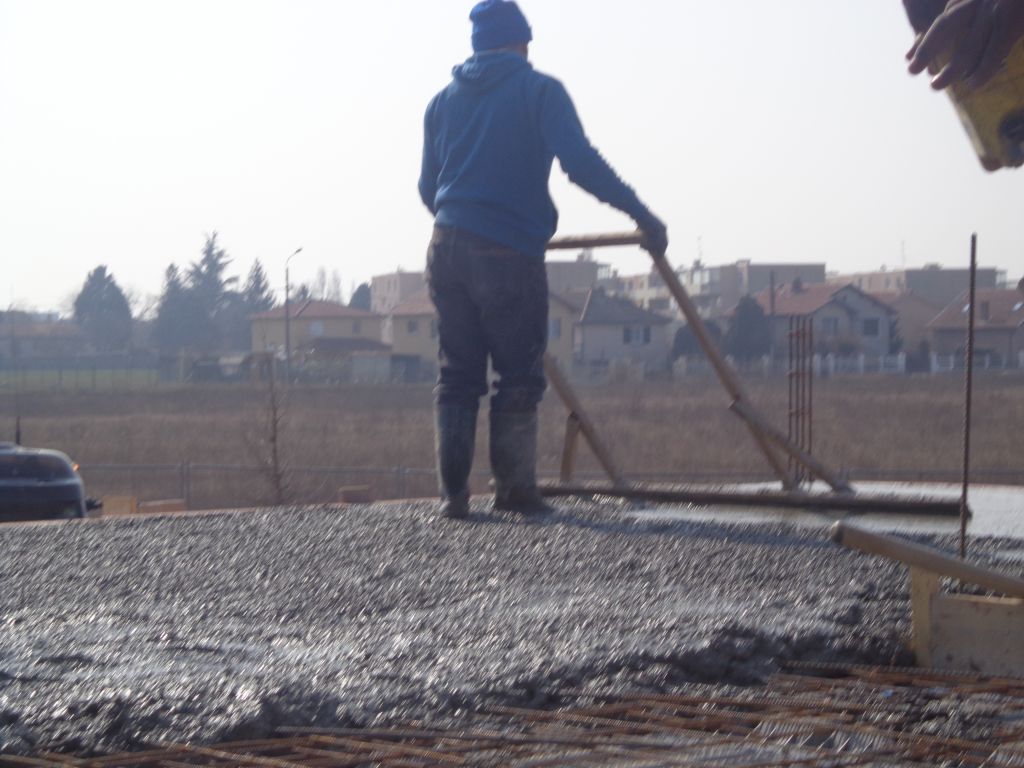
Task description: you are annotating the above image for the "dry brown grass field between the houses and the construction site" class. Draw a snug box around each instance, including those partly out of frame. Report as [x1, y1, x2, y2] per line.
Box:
[0, 376, 1024, 506]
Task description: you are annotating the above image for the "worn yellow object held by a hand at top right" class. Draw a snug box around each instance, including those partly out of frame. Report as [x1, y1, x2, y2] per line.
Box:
[934, 39, 1024, 171]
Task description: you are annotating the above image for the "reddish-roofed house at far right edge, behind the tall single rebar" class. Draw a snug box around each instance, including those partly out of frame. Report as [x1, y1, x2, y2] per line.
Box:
[928, 288, 1024, 367]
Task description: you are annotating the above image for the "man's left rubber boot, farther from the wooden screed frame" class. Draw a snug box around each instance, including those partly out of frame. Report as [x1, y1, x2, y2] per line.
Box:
[434, 403, 477, 520]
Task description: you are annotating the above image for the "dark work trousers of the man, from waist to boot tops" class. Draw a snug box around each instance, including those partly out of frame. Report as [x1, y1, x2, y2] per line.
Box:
[427, 226, 548, 412]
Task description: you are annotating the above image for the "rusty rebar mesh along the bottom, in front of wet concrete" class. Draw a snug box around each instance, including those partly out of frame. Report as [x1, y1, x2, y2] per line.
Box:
[25, 667, 1024, 768]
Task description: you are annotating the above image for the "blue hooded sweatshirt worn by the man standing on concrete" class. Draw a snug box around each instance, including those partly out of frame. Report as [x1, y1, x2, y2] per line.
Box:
[420, 51, 651, 258]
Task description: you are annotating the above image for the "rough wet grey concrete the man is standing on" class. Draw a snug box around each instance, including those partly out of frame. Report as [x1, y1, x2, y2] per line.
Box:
[0, 501, 1011, 754]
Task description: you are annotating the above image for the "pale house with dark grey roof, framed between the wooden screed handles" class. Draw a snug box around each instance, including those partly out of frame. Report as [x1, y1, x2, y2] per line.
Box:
[574, 289, 673, 372]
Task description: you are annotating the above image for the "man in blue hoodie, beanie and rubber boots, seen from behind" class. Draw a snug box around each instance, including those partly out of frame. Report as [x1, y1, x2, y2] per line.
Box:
[420, 0, 668, 518]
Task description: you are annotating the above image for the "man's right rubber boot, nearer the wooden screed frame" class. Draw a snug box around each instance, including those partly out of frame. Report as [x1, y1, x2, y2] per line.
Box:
[490, 409, 554, 515]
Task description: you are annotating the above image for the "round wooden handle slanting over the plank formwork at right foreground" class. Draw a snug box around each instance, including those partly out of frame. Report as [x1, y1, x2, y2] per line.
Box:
[831, 522, 1024, 598]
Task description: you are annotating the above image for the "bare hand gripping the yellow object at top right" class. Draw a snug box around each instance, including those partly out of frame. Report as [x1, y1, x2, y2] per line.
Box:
[906, 0, 1024, 90]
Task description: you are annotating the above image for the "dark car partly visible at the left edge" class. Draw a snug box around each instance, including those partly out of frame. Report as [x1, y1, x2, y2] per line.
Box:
[0, 442, 98, 522]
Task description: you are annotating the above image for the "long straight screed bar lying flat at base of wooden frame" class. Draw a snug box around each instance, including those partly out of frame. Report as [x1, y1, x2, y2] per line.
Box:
[541, 483, 959, 517]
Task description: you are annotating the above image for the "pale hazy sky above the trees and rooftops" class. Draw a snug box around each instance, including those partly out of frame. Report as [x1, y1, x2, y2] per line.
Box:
[0, 0, 1024, 309]
